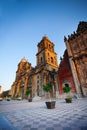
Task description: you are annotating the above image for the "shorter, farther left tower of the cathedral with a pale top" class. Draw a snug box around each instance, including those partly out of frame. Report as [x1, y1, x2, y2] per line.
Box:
[11, 58, 32, 98]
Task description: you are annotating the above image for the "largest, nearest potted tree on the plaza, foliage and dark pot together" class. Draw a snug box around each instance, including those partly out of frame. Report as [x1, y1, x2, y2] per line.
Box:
[43, 83, 56, 109]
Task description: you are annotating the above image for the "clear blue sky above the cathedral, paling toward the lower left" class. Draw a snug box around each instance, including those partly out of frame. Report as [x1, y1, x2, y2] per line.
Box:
[0, 0, 87, 91]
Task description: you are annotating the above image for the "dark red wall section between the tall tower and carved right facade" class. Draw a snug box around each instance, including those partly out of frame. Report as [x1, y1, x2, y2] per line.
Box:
[58, 50, 76, 95]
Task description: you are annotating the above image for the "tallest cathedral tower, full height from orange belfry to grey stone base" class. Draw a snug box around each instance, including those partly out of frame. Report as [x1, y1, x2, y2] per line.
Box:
[36, 36, 58, 96]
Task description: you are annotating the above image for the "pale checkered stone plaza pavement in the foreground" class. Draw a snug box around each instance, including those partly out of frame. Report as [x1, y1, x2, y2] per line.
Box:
[0, 98, 87, 130]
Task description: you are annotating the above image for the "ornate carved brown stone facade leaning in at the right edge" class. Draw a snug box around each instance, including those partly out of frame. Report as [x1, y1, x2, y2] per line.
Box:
[64, 22, 87, 97]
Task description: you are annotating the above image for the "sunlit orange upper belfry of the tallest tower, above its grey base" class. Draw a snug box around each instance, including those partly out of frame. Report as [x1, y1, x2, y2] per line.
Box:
[36, 36, 58, 69]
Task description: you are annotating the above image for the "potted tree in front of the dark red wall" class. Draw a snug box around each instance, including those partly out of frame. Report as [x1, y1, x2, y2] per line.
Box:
[63, 84, 72, 103]
